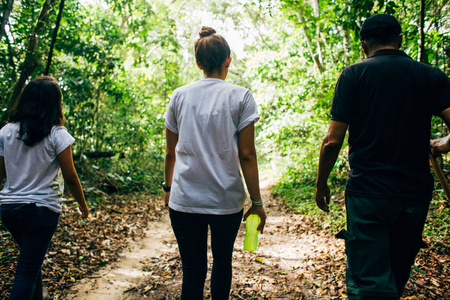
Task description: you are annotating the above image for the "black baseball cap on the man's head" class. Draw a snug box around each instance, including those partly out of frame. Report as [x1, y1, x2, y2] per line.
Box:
[359, 14, 402, 40]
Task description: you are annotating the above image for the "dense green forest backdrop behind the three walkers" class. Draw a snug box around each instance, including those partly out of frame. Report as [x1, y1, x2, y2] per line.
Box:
[0, 0, 450, 236]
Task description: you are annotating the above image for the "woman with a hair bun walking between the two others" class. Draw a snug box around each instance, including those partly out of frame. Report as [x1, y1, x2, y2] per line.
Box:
[163, 27, 266, 300]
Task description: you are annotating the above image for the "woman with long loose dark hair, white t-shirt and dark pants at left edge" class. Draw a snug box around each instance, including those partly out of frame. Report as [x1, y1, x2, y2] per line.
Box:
[0, 76, 89, 300]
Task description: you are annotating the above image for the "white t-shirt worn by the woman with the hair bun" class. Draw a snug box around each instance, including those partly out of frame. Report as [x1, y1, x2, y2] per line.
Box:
[164, 78, 259, 215]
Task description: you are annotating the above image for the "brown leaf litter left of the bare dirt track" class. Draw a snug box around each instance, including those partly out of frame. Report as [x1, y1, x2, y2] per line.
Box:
[0, 194, 162, 299]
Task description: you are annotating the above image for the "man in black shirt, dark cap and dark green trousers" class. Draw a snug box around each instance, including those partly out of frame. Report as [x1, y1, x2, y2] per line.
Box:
[315, 14, 450, 300]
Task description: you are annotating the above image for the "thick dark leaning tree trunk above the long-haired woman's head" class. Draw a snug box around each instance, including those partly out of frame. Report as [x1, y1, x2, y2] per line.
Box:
[8, 0, 56, 110]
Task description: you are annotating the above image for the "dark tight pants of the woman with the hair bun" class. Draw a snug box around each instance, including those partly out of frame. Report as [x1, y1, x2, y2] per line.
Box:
[170, 209, 243, 300]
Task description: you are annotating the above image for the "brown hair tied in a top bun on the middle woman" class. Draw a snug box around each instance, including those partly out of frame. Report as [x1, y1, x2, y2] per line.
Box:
[194, 26, 231, 74]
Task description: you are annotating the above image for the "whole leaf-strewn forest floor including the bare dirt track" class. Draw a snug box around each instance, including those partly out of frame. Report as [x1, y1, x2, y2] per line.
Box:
[0, 177, 450, 300]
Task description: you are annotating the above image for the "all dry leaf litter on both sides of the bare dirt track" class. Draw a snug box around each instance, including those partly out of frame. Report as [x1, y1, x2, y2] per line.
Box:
[0, 195, 450, 300]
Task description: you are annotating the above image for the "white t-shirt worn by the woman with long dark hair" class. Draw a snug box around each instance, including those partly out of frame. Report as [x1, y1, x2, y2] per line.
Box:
[0, 123, 75, 213]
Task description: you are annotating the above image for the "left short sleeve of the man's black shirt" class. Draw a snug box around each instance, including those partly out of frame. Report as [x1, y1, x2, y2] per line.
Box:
[331, 69, 357, 124]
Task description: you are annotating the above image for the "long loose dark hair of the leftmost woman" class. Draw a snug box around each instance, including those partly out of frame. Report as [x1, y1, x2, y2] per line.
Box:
[9, 76, 64, 147]
